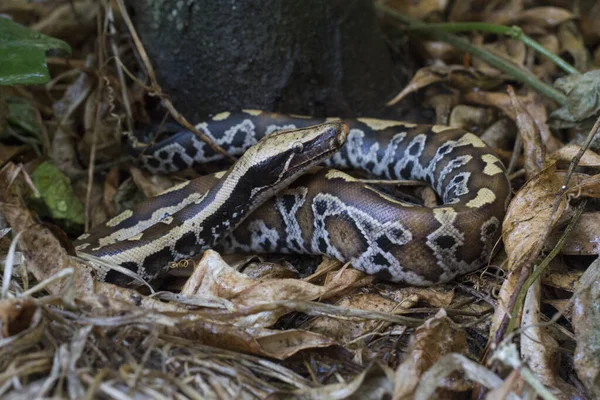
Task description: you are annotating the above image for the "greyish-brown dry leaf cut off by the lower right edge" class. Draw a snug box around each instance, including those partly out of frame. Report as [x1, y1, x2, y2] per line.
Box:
[573, 259, 600, 397]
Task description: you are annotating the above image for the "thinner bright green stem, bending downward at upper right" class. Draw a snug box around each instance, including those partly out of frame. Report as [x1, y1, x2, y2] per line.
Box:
[407, 22, 579, 74]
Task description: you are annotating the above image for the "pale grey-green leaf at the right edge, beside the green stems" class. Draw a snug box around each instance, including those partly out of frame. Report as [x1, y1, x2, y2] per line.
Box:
[550, 70, 600, 126]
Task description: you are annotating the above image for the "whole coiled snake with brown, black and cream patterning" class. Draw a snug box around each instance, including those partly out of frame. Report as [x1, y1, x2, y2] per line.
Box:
[75, 110, 510, 286]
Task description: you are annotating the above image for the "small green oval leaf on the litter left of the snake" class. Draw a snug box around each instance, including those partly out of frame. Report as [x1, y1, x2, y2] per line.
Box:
[30, 161, 85, 232]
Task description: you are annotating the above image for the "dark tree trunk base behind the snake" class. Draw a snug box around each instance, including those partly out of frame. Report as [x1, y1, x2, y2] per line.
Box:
[129, 0, 414, 121]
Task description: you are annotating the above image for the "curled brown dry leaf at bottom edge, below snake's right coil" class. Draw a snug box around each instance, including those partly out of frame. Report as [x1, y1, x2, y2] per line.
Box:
[394, 309, 470, 400]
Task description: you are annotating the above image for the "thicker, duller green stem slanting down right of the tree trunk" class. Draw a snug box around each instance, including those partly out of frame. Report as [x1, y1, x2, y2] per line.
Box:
[377, 4, 567, 105]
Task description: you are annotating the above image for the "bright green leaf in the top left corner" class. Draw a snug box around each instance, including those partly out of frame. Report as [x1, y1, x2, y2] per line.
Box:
[0, 17, 71, 85]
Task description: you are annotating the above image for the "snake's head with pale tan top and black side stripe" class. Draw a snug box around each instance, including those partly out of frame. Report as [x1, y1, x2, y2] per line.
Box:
[230, 121, 348, 201]
